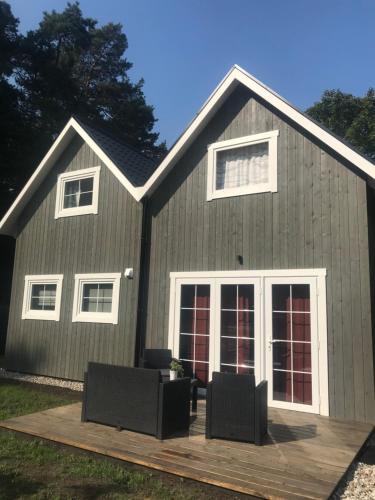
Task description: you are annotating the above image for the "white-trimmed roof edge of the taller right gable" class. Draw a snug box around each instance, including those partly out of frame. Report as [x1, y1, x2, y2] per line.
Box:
[139, 65, 375, 198]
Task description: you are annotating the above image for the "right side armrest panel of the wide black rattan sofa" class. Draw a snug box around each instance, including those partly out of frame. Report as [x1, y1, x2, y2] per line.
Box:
[157, 378, 190, 439]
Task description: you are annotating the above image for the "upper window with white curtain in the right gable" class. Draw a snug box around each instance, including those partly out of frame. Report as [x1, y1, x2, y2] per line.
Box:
[207, 130, 279, 200]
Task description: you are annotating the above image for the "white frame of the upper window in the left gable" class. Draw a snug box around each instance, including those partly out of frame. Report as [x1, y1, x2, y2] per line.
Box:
[55, 167, 100, 219]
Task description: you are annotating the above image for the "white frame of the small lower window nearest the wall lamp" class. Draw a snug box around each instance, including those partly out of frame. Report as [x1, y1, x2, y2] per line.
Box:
[72, 273, 121, 325]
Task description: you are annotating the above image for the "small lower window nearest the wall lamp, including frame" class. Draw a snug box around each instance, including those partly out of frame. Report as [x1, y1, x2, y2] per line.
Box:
[72, 273, 121, 325]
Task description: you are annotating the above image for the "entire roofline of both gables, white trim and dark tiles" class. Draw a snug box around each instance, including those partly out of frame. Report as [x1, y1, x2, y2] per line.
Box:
[0, 65, 375, 235]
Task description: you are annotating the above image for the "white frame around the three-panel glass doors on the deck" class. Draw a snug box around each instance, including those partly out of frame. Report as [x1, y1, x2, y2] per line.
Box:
[168, 268, 329, 416]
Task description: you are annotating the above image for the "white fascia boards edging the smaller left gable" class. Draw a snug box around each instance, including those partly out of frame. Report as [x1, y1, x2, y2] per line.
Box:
[0, 118, 141, 236]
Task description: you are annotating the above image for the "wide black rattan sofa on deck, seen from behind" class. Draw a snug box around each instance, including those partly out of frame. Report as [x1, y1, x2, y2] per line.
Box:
[81, 363, 190, 439]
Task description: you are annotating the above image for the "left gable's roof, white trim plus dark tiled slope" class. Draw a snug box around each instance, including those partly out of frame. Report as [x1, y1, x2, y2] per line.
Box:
[0, 117, 156, 236]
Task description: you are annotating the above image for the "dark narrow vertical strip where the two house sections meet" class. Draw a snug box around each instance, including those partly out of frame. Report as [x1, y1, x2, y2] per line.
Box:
[134, 198, 148, 366]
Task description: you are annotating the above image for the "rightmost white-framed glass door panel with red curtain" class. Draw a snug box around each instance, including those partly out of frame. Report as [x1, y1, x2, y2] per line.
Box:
[265, 277, 319, 413]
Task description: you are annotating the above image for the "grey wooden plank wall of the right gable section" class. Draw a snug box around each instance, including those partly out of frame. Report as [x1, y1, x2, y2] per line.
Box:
[143, 87, 375, 420]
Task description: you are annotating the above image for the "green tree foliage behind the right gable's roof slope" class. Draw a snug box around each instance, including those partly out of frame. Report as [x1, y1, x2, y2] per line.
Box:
[307, 88, 375, 159]
